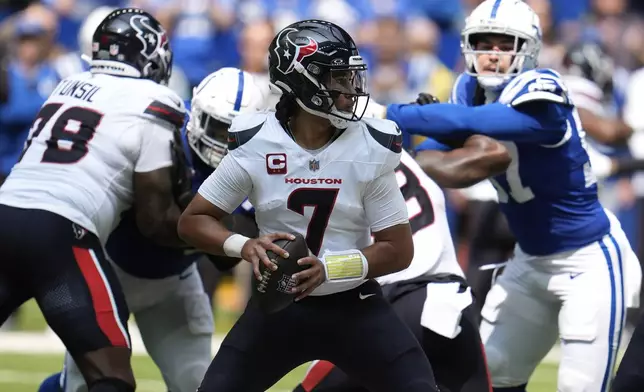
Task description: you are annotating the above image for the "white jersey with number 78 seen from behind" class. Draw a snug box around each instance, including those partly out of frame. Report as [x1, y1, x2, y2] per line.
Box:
[0, 72, 185, 242]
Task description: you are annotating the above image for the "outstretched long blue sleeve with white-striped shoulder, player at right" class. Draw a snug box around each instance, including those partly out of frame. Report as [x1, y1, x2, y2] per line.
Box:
[387, 70, 572, 144]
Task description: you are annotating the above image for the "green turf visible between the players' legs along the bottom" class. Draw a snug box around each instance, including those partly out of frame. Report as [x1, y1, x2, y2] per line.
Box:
[0, 301, 557, 392]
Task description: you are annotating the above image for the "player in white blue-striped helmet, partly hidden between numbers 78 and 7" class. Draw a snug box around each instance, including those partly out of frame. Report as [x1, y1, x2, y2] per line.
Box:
[39, 68, 265, 392]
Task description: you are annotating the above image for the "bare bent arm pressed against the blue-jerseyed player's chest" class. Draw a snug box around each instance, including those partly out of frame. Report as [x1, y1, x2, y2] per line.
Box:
[416, 135, 511, 188]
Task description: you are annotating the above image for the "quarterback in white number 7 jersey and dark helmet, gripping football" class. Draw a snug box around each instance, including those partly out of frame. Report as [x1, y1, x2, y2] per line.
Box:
[179, 20, 437, 392]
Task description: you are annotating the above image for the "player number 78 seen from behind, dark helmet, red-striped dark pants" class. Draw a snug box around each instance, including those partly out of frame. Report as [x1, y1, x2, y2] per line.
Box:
[0, 9, 188, 392]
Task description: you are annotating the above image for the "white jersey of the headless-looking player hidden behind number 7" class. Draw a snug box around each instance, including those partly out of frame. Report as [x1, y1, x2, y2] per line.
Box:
[377, 151, 465, 284]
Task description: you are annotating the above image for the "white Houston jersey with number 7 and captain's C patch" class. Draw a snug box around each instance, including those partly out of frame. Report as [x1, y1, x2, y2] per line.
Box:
[199, 112, 408, 295]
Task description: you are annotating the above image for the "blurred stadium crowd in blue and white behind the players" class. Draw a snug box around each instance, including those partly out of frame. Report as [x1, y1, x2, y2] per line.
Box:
[0, 0, 644, 318]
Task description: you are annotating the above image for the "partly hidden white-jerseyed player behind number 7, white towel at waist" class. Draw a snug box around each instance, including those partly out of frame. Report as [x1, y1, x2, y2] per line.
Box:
[294, 136, 510, 392]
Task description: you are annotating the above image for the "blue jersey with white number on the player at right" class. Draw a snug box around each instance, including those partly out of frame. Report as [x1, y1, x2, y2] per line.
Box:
[452, 69, 610, 255]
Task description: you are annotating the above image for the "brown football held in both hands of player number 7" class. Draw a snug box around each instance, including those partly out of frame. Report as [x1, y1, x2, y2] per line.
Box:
[253, 233, 309, 313]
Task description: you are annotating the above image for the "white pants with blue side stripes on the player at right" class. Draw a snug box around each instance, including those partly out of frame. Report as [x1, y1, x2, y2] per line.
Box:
[480, 214, 641, 392]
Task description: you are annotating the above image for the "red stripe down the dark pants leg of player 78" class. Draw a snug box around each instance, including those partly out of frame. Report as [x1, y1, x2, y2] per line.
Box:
[72, 247, 128, 347]
